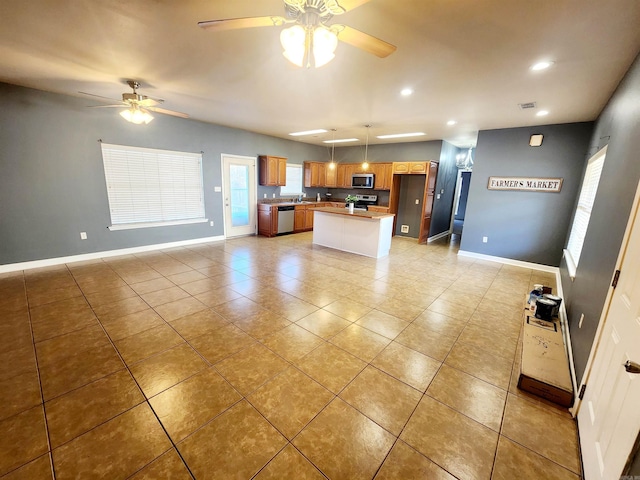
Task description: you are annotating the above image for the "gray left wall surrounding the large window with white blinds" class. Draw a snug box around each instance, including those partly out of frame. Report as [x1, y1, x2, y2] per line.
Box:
[0, 80, 326, 264]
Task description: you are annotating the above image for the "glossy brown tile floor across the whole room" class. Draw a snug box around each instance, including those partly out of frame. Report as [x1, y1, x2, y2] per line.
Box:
[0, 234, 580, 480]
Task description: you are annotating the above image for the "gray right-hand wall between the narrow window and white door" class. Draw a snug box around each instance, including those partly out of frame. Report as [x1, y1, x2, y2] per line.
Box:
[560, 51, 640, 381]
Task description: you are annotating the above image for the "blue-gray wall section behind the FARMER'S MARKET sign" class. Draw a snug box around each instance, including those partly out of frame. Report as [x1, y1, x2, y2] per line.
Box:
[460, 122, 593, 266]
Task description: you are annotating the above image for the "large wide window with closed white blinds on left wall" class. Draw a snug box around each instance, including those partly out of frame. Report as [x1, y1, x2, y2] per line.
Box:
[102, 143, 207, 230]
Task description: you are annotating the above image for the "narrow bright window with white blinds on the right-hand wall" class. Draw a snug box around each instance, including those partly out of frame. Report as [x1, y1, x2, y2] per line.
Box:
[565, 147, 607, 277]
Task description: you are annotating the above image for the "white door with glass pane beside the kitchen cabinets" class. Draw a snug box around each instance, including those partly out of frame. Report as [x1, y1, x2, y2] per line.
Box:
[222, 154, 257, 238]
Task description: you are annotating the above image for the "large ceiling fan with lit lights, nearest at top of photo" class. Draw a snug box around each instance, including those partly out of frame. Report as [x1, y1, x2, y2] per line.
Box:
[198, 0, 396, 68]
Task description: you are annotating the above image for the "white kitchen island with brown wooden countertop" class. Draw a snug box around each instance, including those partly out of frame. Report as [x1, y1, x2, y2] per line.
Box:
[313, 207, 394, 258]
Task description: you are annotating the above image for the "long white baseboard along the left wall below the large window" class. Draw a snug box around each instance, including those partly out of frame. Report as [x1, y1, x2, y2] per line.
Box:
[0, 235, 225, 273]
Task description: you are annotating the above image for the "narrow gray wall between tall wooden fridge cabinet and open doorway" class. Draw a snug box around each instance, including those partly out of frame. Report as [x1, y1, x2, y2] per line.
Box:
[429, 141, 461, 237]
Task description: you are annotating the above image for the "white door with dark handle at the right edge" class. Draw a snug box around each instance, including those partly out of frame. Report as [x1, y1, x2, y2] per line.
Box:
[578, 181, 640, 480]
